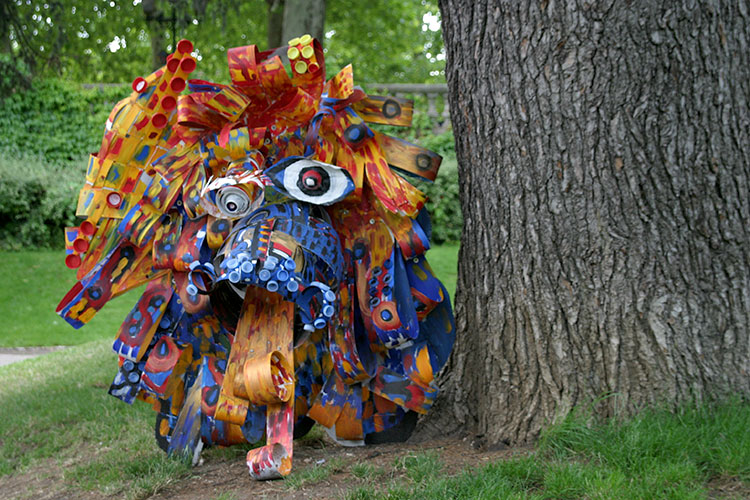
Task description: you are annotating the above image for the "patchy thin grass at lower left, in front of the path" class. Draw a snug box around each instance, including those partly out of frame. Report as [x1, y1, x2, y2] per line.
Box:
[0, 341, 190, 498]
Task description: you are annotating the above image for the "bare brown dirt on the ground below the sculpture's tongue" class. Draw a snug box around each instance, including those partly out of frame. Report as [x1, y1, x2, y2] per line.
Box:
[0, 437, 530, 500]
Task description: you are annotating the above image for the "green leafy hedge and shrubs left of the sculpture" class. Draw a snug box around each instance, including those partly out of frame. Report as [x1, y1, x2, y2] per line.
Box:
[0, 80, 129, 250]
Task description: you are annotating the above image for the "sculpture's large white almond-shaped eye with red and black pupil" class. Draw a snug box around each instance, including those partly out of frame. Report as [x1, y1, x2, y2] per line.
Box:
[265, 157, 354, 205]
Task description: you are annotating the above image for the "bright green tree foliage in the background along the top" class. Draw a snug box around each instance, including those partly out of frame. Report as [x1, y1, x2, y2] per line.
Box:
[0, 0, 444, 83]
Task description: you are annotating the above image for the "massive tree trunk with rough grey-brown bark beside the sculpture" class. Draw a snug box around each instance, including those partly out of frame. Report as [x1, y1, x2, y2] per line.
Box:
[427, 0, 750, 443]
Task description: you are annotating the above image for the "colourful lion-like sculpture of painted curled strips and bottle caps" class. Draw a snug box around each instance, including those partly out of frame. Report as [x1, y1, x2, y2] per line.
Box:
[57, 35, 454, 479]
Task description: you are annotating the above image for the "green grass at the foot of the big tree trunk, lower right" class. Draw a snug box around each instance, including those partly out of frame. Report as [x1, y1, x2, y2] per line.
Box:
[347, 400, 750, 500]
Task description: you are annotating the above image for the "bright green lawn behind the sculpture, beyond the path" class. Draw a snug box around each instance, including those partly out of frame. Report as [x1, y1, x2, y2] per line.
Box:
[0, 245, 458, 347]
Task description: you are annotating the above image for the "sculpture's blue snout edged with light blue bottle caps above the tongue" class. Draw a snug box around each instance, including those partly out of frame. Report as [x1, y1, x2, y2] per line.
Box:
[194, 202, 343, 352]
